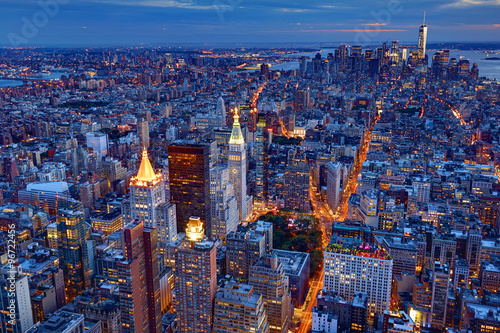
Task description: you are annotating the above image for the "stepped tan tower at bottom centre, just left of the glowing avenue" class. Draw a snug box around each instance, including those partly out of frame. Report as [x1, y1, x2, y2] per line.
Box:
[248, 254, 293, 333]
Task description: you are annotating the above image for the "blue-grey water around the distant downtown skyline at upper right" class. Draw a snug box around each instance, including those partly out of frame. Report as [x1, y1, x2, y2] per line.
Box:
[272, 49, 500, 81]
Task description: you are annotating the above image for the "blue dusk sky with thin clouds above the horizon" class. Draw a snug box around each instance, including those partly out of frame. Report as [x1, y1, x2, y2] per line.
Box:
[0, 0, 500, 46]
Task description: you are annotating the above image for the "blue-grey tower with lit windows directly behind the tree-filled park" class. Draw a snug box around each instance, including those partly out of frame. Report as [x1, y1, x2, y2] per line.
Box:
[284, 149, 310, 212]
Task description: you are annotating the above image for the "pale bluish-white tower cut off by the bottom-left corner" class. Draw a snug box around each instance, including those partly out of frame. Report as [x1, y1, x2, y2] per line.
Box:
[0, 264, 33, 333]
